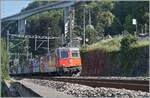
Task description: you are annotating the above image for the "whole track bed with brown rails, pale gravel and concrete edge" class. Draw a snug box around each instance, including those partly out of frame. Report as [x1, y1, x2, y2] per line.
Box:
[11, 76, 150, 98]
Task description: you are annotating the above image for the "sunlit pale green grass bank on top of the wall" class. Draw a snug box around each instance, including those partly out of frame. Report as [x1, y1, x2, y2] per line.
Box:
[81, 37, 149, 52]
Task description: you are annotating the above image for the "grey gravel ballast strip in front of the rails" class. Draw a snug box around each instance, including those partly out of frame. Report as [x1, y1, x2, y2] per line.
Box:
[25, 79, 150, 98]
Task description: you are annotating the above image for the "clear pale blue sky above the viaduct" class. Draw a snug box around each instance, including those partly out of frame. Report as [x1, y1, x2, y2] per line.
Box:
[0, 0, 32, 18]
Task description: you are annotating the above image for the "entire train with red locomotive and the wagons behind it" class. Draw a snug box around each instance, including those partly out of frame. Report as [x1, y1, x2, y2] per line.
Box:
[9, 47, 81, 76]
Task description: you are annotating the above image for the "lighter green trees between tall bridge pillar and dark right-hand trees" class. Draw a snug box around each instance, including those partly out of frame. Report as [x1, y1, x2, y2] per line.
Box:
[75, 1, 114, 43]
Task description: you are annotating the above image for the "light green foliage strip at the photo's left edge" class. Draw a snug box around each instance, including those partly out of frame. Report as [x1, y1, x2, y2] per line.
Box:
[0, 39, 9, 79]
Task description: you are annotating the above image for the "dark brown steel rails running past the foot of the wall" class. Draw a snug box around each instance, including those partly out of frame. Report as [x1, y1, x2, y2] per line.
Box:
[48, 77, 149, 92]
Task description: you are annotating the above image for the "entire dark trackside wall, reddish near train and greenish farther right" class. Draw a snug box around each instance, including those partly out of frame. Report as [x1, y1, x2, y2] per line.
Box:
[81, 46, 149, 76]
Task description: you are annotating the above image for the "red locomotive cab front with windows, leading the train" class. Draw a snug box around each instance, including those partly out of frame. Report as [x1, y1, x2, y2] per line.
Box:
[56, 47, 81, 73]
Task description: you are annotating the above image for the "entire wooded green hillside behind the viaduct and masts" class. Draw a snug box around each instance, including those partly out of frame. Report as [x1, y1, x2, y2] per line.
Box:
[2, 0, 149, 54]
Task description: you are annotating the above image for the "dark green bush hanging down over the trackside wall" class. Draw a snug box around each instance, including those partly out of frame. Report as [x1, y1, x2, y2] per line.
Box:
[121, 35, 139, 74]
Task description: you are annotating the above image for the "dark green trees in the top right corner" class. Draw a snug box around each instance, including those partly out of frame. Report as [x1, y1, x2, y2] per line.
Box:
[112, 1, 149, 33]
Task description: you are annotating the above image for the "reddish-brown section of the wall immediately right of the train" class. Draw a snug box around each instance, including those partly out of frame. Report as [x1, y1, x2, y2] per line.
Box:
[81, 50, 107, 76]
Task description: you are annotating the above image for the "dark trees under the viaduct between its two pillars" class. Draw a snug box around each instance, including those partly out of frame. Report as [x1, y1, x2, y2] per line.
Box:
[24, 5, 63, 55]
